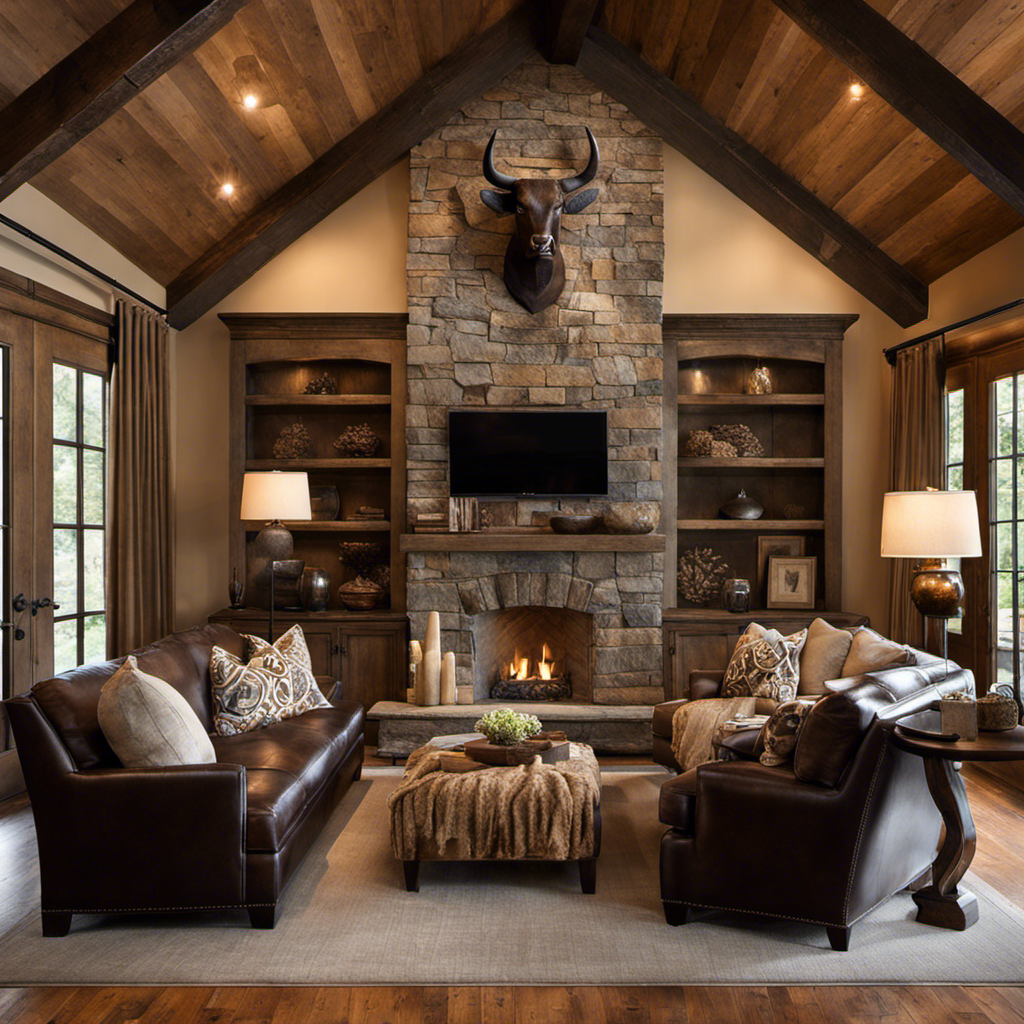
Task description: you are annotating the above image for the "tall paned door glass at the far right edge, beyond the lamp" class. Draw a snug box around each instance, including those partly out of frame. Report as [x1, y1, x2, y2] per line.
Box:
[988, 374, 1024, 683]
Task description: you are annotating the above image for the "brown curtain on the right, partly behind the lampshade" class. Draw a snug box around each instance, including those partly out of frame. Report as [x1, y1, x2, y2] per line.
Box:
[889, 338, 946, 647]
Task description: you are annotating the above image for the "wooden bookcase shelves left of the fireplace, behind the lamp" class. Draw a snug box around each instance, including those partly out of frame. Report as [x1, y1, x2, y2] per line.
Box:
[220, 313, 408, 611]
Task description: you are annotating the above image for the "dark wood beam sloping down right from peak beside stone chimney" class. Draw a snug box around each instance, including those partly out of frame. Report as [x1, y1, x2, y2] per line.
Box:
[577, 27, 928, 327]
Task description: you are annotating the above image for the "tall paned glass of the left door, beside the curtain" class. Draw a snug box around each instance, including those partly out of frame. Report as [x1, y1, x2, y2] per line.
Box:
[53, 362, 106, 675]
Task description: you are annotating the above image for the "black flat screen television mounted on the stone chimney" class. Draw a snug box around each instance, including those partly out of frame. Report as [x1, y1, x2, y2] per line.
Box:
[449, 409, 608, 498]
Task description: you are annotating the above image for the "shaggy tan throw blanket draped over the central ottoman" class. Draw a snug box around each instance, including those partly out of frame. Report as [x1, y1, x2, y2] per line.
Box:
[388, 743, 601, 860]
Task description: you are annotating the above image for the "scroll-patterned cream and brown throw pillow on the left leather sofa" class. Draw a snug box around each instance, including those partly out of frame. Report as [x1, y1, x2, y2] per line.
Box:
[210, 626, 323, 736]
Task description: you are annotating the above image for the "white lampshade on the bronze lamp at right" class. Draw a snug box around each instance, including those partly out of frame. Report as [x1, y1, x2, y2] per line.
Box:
[882, 490, 981, 558]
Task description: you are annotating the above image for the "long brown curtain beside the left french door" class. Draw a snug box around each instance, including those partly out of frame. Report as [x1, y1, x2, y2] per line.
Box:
[106, 300, 174, 657]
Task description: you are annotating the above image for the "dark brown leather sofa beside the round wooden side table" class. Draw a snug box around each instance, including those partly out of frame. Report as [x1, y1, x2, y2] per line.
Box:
[659, 655, 974, 949]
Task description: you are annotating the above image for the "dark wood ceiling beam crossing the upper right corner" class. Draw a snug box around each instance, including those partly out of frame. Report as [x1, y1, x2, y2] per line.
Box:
[773, 0, 1024, 214]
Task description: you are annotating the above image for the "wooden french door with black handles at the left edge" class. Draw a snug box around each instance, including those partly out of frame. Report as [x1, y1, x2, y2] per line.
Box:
[0, 292, 109, 752]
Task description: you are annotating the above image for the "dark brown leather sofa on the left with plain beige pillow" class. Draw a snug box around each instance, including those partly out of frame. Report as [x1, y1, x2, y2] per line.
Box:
[5, 625, 364, 935]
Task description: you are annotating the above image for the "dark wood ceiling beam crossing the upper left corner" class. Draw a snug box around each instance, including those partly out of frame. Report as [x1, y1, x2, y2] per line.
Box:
[0, 0, 248, 200]
